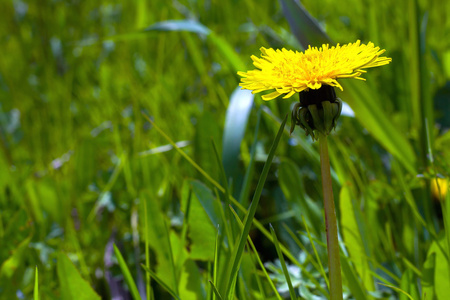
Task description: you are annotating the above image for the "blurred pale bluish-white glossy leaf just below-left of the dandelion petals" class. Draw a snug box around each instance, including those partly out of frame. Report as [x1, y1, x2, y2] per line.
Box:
[222, 88, 254, 182]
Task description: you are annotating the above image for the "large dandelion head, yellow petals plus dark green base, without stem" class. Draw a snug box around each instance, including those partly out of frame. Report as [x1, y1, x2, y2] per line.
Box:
[238, 40, 392, 139]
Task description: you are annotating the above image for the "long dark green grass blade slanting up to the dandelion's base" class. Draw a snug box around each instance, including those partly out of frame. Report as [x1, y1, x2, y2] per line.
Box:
[224, 115, 287, 299]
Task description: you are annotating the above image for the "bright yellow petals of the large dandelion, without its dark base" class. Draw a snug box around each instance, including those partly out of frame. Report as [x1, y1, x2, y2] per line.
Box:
[238, 40, 392, 100]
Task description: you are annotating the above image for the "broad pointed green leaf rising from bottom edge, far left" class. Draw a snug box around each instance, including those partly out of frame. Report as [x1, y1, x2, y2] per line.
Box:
[57, 252, 101, 300]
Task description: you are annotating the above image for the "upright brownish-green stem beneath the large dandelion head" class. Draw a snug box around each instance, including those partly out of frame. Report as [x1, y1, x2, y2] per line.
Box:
[319, 132, 342, 300]
